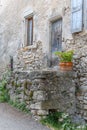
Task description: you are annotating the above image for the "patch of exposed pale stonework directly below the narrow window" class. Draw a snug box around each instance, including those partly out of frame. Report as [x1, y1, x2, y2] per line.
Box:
[14, 41, 46, 71]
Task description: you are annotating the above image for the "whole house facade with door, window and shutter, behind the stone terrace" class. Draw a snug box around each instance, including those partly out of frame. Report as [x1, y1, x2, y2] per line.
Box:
[0, 0, 87, 119]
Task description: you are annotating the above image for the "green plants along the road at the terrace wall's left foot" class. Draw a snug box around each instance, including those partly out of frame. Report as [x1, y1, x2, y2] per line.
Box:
[0, 70, 30, 113]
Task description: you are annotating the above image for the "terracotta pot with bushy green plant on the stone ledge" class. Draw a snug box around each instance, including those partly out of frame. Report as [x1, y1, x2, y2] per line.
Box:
[55, 50, 74, 70]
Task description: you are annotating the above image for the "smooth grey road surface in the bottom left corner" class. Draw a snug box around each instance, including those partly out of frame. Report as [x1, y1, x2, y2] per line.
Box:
[0, 103, 49, 130]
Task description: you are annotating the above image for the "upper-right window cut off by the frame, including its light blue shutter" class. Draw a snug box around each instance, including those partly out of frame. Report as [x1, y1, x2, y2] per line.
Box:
[71, 0, 87, 33]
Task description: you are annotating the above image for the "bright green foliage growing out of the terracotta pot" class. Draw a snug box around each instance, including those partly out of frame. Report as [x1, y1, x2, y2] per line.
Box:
[55, 50, 74, 62]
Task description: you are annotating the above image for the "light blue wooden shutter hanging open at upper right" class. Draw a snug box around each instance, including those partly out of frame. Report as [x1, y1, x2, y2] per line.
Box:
[71, 0, 83, 33]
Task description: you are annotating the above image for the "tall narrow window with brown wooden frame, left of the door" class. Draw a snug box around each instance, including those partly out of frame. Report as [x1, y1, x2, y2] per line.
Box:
[26, 18, 33, 46]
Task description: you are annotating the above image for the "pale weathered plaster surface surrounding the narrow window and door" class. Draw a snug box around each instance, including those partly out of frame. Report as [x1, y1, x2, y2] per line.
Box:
[0, 0, 71, 71]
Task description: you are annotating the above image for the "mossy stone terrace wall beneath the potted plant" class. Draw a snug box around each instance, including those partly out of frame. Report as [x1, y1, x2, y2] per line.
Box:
[7, 70, 76, 117]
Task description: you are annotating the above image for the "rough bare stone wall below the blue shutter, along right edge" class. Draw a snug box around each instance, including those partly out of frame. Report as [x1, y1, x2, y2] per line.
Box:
[71, 34, 87, 120]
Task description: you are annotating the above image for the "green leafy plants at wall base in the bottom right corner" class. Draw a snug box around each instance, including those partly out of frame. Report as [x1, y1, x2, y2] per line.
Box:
[41, 112, 87, 130]
